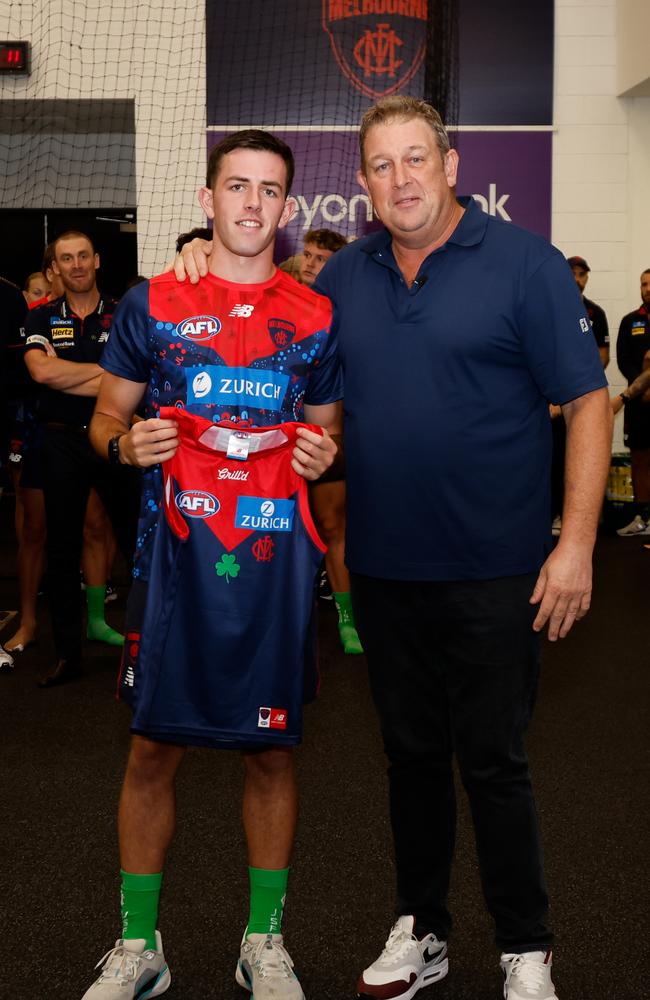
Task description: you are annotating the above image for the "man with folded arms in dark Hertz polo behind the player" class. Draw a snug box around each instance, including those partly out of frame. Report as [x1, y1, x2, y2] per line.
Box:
[25, 230, 140, 687]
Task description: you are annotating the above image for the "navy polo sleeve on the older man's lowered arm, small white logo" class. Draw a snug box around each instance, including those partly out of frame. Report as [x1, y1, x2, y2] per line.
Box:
[519, 251, 607, 404]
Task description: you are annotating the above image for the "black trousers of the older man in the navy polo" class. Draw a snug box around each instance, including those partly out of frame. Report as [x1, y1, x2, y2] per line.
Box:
[352, 574, 552, 952]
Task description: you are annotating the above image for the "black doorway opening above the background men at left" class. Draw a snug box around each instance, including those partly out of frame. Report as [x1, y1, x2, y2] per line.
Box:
[0, 208, 138, 298]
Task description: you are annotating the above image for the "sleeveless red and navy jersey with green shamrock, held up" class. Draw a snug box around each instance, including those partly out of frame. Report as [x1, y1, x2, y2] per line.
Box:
[127, 408, 325, 747]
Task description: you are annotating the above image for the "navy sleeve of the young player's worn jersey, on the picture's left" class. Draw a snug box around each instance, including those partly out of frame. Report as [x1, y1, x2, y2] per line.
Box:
[100, 281, 151, 382]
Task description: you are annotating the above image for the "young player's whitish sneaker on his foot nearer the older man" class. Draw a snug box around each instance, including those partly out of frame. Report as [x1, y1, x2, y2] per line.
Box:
[235, 934, 305, 1000]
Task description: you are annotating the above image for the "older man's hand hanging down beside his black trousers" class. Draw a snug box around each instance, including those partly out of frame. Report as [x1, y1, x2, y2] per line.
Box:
[530, 540, 592, 642]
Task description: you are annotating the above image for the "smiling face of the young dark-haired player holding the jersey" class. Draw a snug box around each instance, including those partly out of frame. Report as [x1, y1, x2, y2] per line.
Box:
[199, 149, 295, 257]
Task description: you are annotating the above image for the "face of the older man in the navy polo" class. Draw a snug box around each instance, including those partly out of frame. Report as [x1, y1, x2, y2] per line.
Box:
[357, 118, 458, 249]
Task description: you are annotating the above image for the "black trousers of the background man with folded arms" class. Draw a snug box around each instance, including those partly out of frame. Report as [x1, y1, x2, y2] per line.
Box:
[41, 426, 140, 659]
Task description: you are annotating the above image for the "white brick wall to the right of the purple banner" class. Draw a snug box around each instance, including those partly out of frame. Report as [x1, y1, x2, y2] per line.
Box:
[552, 0, 650, 451]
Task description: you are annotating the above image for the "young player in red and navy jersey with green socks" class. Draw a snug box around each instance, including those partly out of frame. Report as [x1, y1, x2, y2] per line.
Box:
[84, 129, 342, 1000]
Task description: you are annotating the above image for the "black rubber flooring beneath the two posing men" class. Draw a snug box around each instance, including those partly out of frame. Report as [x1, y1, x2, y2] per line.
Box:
[0, 497, 650, 1000]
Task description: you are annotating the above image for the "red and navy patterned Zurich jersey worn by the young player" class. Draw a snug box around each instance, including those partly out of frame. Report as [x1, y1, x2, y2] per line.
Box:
[101, 271, 343, 580]
